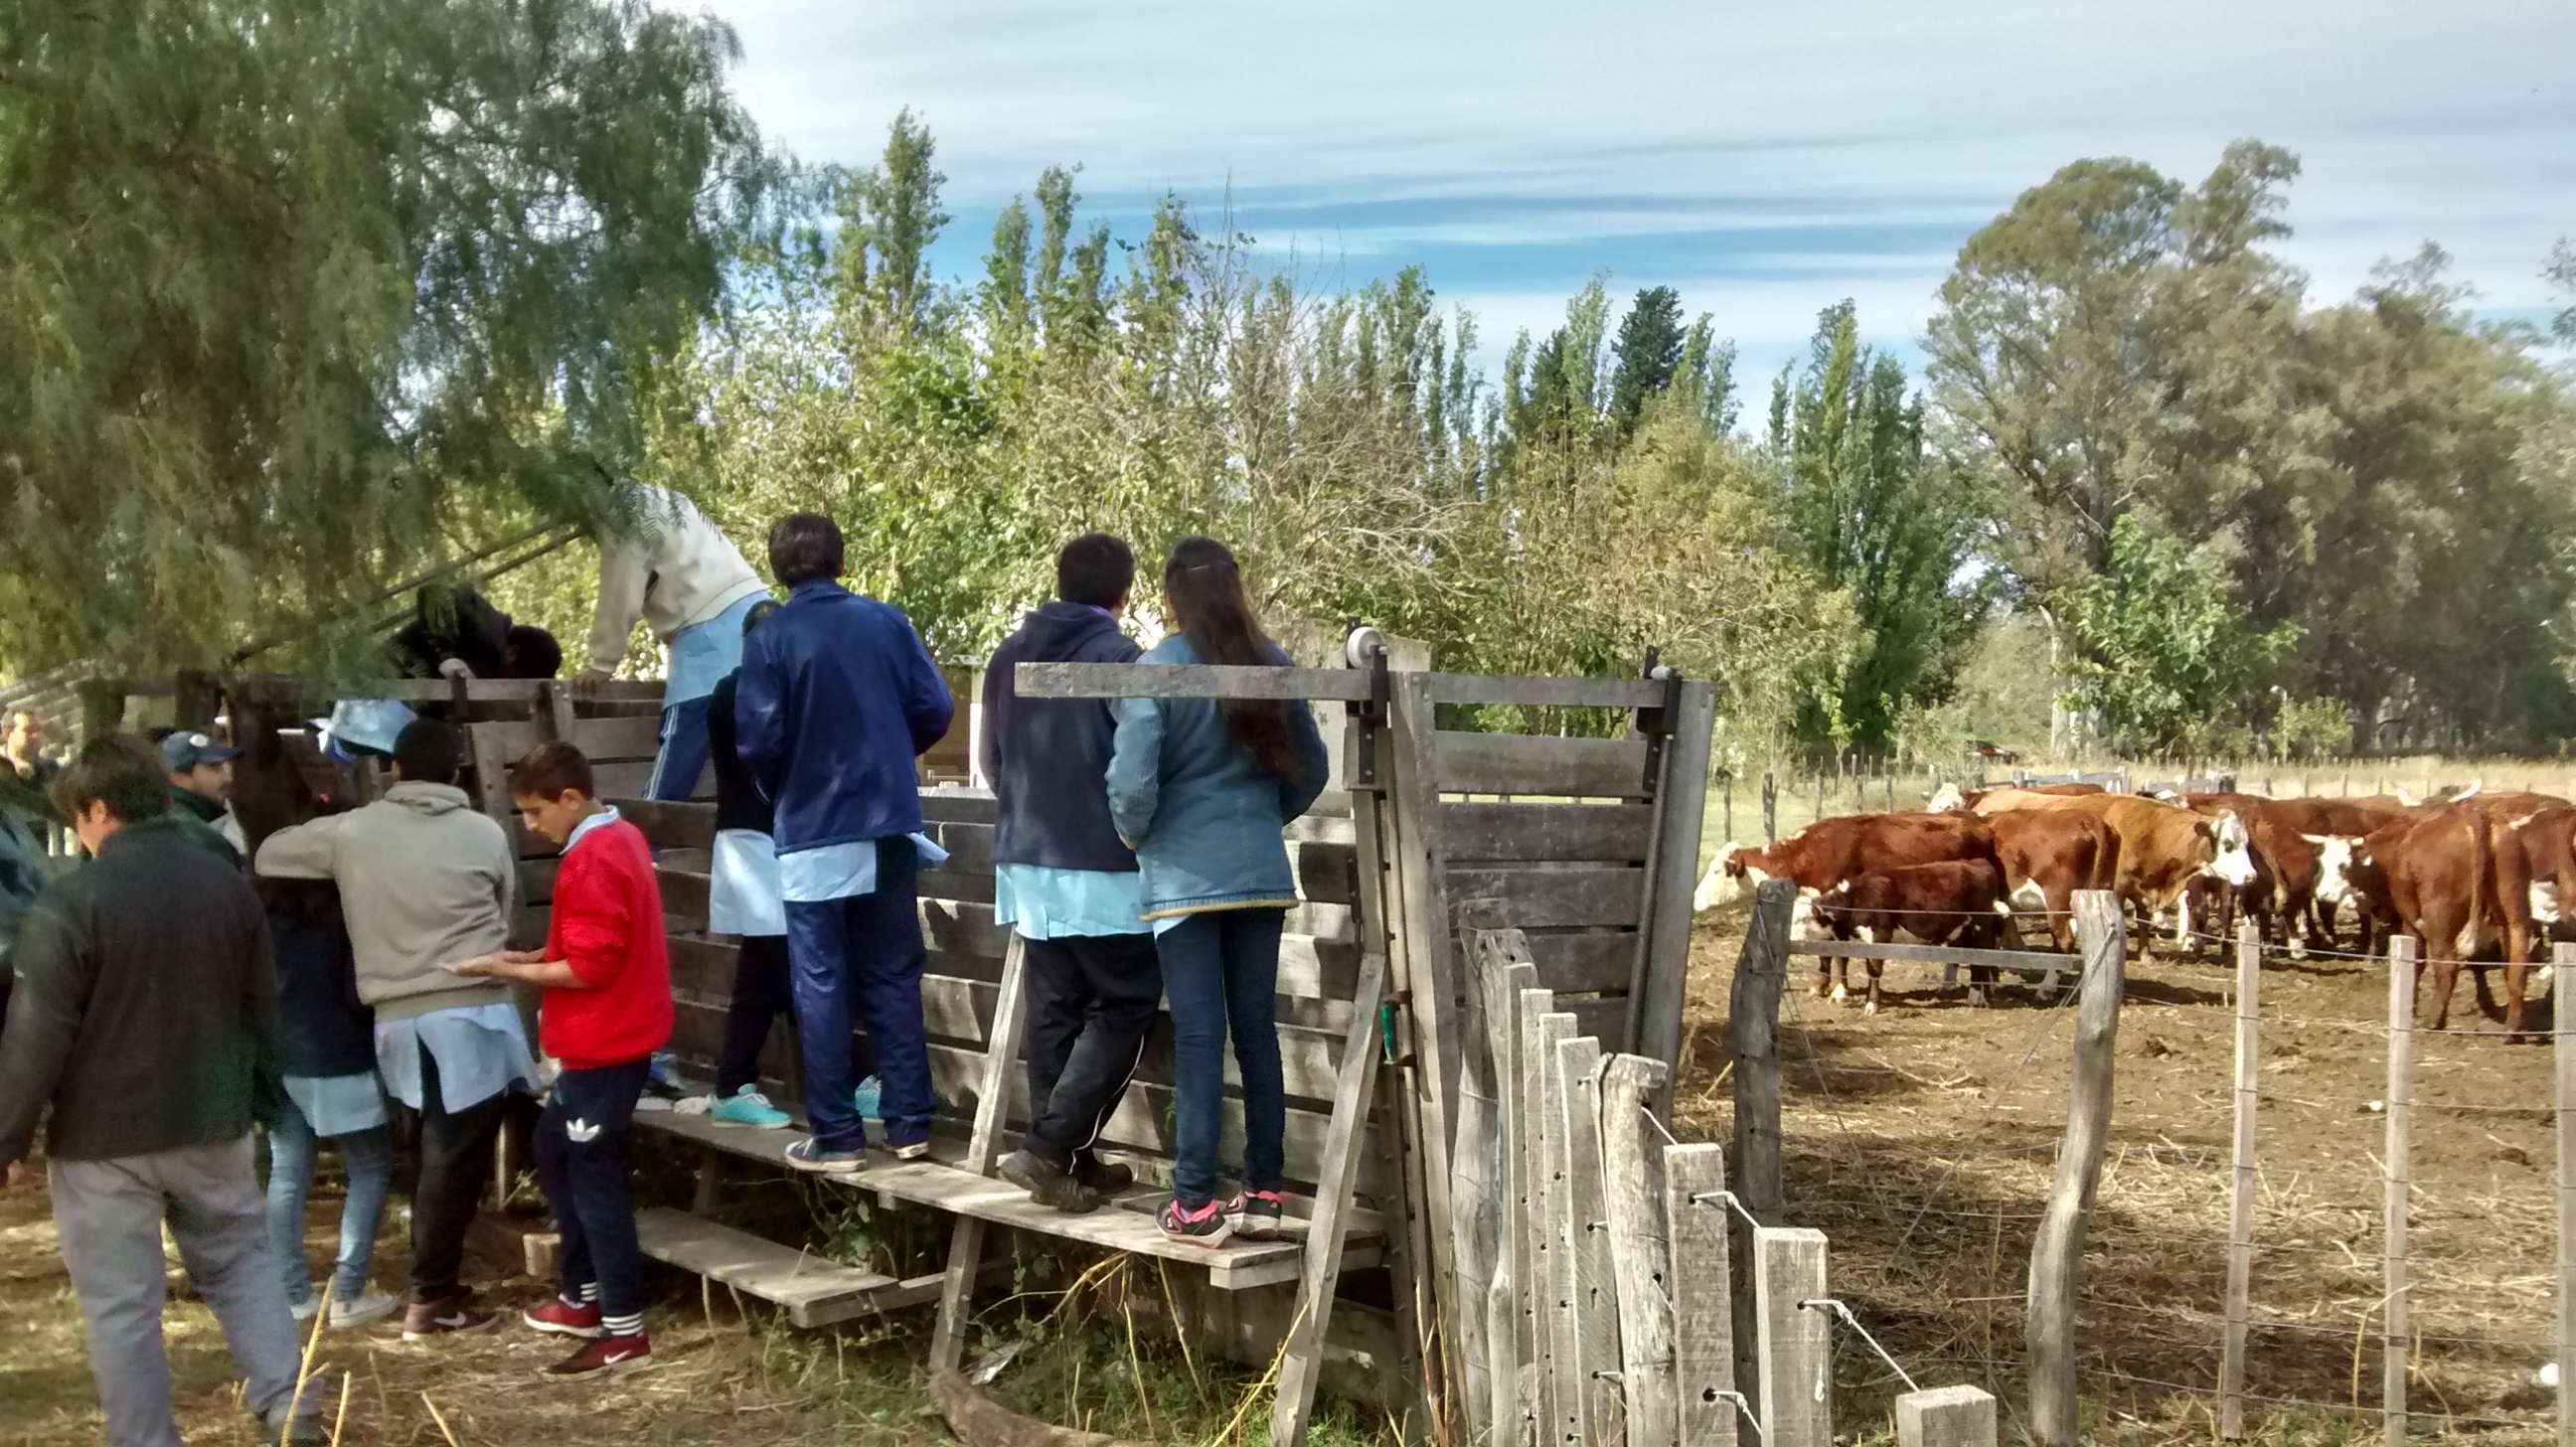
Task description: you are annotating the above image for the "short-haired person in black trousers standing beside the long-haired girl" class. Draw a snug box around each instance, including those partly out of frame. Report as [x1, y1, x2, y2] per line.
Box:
[982, 533, 1162, 1210]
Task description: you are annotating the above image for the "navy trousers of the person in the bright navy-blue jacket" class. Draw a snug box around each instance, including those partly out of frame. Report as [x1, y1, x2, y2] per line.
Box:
[788, 840, 937, 1151]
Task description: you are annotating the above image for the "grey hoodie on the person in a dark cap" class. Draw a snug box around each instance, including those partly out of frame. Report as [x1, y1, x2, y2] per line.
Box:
[257, 783, 518, 1020]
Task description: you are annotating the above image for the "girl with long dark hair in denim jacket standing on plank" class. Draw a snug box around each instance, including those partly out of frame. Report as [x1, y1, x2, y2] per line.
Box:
[1108, 538, 1329, 1243]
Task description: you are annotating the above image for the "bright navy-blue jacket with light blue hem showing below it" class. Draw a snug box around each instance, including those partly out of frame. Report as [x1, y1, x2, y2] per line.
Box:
[734, 579, 956, 855]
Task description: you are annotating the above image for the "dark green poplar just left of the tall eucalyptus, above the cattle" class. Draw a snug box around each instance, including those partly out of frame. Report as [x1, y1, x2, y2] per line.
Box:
[1770, 301, 1986, 749]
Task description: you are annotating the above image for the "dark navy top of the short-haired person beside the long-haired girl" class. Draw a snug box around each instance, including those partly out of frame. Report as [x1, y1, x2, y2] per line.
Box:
[984, 602, 1144, 873]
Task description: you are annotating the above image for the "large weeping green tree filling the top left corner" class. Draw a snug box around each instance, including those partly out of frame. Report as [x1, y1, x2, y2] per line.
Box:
[0, 0, 770, 670]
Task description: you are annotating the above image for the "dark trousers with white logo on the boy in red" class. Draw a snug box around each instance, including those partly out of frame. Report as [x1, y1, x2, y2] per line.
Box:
[536, 1058, 652, 1316]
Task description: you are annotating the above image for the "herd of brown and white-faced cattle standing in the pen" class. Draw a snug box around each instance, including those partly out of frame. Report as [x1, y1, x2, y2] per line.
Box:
[1695, 783, 2576, 1041]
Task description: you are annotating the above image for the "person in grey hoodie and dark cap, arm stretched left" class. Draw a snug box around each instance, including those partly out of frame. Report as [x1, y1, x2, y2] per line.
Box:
[257, 719, 536, 1342]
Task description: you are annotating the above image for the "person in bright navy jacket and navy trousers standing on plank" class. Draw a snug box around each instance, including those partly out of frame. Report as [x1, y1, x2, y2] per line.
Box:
[734, 513, 956, 1174]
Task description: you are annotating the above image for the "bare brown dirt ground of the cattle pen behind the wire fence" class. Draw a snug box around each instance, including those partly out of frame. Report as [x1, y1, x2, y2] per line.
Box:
[1677, 909, 2558, 1442]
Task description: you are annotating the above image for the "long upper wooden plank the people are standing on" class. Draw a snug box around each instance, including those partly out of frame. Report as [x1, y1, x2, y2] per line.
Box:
[636, 1110, 1383, 1290]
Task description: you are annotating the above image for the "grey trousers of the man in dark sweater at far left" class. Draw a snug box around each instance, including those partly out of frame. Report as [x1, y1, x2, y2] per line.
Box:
[47, 1136, 322, 1447]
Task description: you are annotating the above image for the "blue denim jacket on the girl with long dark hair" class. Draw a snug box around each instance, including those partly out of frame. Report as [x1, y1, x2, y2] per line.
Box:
[1110, 636, 1329, 919]
